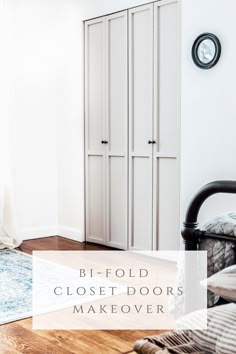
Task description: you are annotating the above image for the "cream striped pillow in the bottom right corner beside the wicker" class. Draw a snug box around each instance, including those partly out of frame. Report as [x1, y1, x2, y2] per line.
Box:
[188, 303, 236, 354]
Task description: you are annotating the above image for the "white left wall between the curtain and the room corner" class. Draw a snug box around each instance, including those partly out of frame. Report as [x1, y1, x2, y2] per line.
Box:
[5, 0, 63, 238]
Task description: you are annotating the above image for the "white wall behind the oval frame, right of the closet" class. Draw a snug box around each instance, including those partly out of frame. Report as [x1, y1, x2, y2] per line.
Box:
[181, 0, 236, 225]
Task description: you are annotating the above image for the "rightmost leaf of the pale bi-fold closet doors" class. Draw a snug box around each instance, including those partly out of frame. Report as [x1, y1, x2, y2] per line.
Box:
[153, 0, 181, 250]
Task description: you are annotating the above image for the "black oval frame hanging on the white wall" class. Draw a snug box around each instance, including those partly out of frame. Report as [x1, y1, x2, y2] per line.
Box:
[192, 33, 221, 69]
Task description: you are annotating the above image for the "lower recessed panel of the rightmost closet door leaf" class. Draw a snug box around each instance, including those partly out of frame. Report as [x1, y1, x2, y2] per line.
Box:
[158, 158, 180, 250]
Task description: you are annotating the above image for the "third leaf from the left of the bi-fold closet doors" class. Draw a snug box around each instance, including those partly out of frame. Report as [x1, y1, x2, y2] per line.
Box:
[129, 4, 153, 250]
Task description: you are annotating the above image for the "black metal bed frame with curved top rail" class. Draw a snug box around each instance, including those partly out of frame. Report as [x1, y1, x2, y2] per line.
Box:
[181, 181, 236, 251]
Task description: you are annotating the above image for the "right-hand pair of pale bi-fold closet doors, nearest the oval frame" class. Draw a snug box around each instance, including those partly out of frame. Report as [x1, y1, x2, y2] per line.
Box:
[129, 0, 180, 250]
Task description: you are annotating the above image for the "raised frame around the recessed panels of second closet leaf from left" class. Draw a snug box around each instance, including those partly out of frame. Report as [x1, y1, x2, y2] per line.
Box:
[105, 11, 128, 249]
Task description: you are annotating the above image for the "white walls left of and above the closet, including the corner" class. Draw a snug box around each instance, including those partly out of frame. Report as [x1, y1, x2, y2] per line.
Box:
[5, 0, 153, 240]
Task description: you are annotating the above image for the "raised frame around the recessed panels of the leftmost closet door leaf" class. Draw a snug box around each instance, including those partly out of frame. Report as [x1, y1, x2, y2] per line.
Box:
[84, 17, 106, 244]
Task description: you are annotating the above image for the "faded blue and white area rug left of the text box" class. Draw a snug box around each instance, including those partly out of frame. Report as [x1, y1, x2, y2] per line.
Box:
[0, 250, 32, 324]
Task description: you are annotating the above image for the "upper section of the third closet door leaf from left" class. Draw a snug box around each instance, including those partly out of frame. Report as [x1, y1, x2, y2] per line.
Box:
[129, 4, 153, 153]
